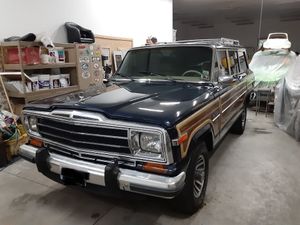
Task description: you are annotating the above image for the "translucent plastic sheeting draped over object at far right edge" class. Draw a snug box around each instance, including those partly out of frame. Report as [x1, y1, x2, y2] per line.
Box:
[274, 56, 300, 141]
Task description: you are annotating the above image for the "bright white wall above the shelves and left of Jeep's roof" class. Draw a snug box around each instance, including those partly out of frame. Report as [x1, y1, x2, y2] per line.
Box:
[0, 0, 173, 46]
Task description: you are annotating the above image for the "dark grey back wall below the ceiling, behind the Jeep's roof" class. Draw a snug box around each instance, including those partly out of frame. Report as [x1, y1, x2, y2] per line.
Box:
[174, 19, 300, 52]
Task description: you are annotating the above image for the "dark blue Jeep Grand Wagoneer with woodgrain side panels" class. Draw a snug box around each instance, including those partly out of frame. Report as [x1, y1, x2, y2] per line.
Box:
[20, 38, 254, 212]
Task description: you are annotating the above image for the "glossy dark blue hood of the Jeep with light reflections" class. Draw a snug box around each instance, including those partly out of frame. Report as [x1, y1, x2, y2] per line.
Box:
[25, 81, 214, 128]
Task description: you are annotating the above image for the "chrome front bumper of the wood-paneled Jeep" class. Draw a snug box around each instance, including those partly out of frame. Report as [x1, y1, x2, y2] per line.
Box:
[19, 145, 185, 198]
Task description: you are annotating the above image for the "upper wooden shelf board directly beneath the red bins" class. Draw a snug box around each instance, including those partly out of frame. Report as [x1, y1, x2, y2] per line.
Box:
[4, 63, 76, 70]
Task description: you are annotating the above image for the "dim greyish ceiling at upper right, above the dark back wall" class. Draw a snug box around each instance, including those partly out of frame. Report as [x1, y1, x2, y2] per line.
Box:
[173, 0, 300, 29]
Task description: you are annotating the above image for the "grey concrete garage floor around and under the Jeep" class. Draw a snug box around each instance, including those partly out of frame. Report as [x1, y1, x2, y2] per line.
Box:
[0, 112, 300, 225]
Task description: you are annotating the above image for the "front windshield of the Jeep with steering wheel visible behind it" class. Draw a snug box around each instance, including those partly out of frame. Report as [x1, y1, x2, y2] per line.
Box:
[115, 46, 212, 81]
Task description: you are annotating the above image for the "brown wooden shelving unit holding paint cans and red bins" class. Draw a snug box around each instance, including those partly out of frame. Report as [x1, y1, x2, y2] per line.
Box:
[0, 41, 82, 111]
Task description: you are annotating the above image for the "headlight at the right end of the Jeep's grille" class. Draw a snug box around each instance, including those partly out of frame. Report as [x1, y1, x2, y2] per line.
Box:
[140, 133, 162, 153]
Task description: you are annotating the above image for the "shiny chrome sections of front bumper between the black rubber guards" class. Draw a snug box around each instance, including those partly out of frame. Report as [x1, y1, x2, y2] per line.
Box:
[19, 145, 185, 198]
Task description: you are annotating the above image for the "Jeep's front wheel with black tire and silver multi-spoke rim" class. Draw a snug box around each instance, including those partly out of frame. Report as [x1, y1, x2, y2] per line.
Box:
[173, 142, 209, 214]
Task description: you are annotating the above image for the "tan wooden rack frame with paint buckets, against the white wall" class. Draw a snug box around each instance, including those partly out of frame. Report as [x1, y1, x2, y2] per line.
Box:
[0, 41, 79, 107]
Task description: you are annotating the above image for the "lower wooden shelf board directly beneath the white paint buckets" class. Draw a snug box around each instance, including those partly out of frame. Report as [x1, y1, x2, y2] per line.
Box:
[8, 85, 79, 102]
